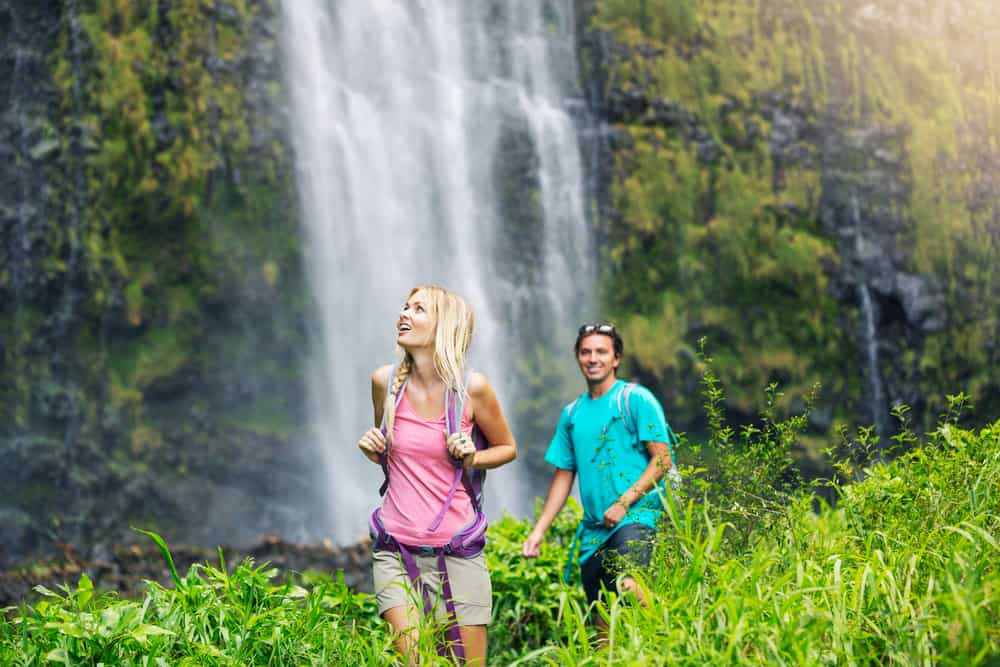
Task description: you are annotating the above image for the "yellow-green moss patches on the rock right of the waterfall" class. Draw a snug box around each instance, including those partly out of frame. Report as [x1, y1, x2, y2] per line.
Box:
[592, 0, 1000, 428]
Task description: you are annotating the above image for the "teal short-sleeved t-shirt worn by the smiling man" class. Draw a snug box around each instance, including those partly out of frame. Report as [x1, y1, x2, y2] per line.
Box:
[545, 380, 677, 564]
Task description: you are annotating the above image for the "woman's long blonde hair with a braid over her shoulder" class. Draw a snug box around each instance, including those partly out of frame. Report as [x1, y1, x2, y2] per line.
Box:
[385, 285, 475, 434]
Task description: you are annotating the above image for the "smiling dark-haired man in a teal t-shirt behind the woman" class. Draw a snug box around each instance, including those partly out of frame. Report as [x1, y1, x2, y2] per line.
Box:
[522, 324, 677, 628]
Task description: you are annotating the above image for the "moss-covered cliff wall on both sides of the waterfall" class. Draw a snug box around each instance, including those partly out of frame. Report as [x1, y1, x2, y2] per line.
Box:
[0, 0, 1000, 565]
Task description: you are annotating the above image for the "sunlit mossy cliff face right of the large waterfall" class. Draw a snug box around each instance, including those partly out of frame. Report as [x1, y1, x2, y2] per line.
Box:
[588, 0, 1000, 429]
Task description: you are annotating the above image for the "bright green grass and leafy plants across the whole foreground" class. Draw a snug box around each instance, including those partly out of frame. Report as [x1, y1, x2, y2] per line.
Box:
[0, 372, 1000, 666]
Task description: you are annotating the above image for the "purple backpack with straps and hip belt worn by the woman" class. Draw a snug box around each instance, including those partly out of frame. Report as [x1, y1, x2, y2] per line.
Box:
[368, 365, 489, 662]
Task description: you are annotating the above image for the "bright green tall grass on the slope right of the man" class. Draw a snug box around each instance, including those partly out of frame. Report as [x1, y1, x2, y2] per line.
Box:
[504, 410, 1000, 666]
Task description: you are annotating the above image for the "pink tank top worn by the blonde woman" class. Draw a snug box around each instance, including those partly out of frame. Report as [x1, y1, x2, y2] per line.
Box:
[381, 391, 475, 547]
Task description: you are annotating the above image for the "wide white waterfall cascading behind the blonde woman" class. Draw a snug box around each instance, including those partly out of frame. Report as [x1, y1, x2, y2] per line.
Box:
[282, 0, 594, 542]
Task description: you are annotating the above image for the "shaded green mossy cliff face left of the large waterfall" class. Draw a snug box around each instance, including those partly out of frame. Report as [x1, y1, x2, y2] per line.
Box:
[0, 0, 308, 550]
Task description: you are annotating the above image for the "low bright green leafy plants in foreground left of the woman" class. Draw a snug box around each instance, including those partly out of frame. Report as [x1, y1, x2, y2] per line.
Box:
[0, 561, 392, 667]
